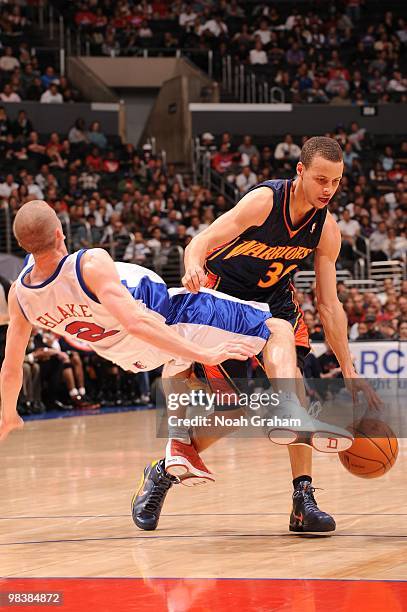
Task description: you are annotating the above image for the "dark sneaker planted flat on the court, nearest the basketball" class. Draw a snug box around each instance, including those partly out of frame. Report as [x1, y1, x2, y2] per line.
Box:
[290, 480, 336, 533]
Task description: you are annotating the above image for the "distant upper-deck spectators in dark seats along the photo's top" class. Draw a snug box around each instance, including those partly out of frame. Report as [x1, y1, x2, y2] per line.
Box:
[54, 0, 407, 105]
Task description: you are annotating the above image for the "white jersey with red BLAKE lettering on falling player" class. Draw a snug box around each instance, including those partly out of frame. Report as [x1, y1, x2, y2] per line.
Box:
[16, 250, 172, 372]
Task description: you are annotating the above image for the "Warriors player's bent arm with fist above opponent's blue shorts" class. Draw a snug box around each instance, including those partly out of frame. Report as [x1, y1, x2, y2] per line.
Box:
[182, 187, 273, 293]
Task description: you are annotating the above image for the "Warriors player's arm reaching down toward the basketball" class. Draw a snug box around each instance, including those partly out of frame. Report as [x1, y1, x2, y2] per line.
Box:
[315, 213, 380, 407]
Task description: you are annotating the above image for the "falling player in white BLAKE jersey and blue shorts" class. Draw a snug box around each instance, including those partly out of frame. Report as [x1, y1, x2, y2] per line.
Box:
[0, 201, 351, 454]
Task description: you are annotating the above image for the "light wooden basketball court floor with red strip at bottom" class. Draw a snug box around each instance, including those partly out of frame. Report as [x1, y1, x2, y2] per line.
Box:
[0, 410, 407, 612]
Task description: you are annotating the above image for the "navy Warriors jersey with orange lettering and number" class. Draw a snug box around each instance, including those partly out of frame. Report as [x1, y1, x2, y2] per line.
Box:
[205, 180, 327, 314]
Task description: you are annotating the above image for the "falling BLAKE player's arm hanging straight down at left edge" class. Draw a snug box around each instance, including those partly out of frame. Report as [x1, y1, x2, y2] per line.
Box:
[0, 285, 32, 441]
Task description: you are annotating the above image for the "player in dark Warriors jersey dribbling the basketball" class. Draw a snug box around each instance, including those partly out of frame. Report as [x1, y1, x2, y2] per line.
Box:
[133, 137, 379, 532]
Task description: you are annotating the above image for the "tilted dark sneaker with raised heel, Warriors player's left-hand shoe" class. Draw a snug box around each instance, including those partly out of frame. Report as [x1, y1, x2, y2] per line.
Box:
[131, 459, 179, 531]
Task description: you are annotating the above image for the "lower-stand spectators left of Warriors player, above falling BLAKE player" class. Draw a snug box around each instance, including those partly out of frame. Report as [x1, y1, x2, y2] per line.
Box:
[0, 107, 226, 269]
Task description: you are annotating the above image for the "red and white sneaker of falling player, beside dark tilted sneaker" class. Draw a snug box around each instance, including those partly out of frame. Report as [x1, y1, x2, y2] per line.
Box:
[165, 439, 215, 487]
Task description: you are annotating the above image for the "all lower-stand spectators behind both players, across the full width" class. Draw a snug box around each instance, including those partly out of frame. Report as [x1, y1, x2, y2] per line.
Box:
[0, 108, 407, 354]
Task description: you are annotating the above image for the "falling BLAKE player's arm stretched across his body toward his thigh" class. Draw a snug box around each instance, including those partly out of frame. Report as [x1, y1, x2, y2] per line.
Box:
[82, 249, 253, 365]
